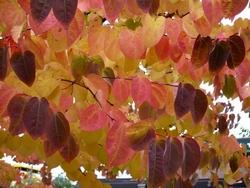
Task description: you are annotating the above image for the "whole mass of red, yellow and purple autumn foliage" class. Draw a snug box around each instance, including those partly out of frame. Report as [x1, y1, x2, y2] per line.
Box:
[0, 0, 250, 187]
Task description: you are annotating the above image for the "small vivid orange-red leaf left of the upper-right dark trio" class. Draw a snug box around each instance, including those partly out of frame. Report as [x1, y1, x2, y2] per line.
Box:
[155, 35, 170, 60]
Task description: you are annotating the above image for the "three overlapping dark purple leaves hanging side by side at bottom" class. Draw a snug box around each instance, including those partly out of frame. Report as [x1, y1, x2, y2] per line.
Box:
[148, 137, 201, 187]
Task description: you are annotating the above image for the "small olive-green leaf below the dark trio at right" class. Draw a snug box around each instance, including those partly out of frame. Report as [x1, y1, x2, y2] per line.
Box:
[222, 75, 236, 98]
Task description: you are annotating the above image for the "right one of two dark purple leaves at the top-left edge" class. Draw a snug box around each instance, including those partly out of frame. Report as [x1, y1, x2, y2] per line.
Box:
[53, 0, 78, 25]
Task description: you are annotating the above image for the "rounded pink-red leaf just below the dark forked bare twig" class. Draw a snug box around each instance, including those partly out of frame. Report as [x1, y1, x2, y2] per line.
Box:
[79, 104, 108, 131]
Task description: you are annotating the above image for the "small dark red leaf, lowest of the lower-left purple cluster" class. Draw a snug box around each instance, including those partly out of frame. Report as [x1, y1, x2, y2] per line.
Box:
[60, 135, 79, 162]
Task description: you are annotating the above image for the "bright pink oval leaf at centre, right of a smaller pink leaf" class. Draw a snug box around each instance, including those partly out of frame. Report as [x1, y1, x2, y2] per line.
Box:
[131, 76, 151, 106]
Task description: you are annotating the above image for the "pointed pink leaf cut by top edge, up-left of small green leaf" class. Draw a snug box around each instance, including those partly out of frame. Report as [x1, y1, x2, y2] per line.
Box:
[103, 0, 125, 23]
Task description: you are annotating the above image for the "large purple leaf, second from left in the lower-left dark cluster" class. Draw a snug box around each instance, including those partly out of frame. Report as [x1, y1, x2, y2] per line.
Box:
[23, 97, 52, 139]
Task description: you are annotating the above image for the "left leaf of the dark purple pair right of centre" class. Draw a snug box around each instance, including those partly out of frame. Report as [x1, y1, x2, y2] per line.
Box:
[174, 83, 195, 118]
